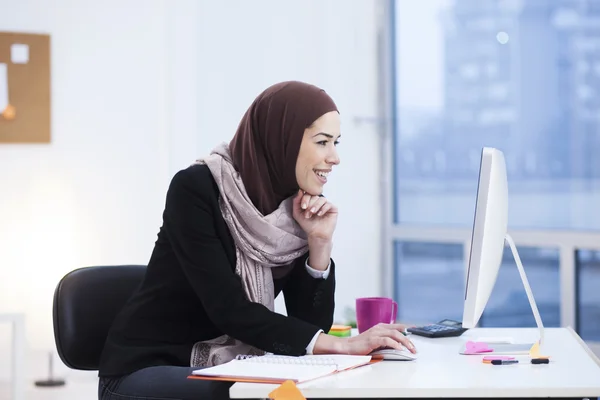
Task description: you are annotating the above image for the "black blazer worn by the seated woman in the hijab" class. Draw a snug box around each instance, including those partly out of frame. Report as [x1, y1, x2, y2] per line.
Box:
[99, 165, 335, 376]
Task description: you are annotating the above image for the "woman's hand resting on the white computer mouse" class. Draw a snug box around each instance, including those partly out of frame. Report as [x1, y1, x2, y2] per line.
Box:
[313, 324, 417, 355]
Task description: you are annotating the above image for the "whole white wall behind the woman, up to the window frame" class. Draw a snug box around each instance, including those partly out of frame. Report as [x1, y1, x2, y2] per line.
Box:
[0, 0, 380, 380]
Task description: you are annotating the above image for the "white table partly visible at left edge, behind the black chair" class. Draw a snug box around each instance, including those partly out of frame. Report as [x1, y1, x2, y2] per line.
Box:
[0, 314, 26, 400]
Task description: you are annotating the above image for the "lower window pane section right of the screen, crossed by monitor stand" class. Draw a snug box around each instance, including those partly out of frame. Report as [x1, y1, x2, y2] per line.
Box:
[479, 246, 560, 327]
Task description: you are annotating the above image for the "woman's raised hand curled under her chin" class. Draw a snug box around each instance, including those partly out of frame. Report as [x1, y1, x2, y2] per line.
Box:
[293, 190, 338, 242]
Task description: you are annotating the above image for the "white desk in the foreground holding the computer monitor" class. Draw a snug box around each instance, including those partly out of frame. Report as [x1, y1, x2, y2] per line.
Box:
[229, 328, 600, 398]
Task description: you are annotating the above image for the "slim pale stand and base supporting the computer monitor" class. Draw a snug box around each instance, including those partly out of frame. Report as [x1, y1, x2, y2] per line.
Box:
[460, 233, 544, 354]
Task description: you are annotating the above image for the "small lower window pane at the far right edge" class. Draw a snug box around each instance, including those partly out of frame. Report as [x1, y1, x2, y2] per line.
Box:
[576, 250, 600, 341]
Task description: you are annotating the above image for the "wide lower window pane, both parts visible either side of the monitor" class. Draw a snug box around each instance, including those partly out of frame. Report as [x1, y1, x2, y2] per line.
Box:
[394, 241, 560, 327]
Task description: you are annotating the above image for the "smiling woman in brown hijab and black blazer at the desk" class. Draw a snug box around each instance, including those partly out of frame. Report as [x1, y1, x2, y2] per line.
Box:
[99, 82, 414, 400]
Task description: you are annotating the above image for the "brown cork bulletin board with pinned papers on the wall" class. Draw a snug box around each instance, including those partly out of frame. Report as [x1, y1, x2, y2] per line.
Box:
[0, 32, 51, 145]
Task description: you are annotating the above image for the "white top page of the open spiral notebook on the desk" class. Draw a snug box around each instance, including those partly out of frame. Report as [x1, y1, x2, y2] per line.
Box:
[192, 360, 336, 382]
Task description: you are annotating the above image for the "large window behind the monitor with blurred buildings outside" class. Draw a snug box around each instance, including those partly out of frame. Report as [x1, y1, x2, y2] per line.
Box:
[384, 0, 600, 341]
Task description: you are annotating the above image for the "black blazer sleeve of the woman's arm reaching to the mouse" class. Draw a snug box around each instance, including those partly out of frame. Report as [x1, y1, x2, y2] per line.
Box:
[164, 168, 319, 355]
